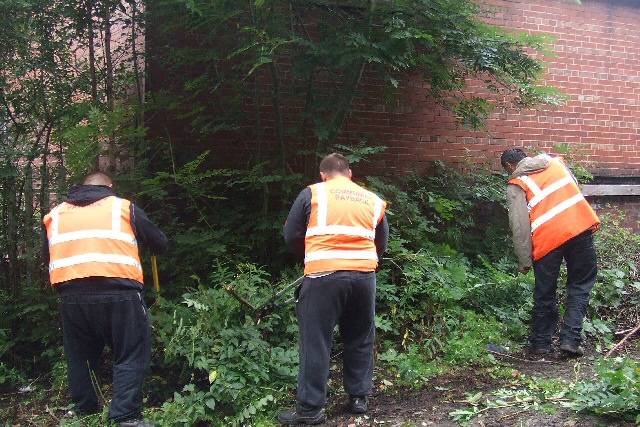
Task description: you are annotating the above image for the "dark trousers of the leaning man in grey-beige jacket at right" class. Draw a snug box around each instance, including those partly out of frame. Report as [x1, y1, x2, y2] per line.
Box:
[530, 230, 598, 348]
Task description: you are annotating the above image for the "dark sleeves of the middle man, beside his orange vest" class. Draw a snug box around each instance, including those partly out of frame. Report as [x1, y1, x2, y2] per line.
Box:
[284, 187, 389, 259]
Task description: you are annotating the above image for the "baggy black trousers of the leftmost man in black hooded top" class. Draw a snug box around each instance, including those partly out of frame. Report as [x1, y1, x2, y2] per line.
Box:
[60, 290, 151, 421]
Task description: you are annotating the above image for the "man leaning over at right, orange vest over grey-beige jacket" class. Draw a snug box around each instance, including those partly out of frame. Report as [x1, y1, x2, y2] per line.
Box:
[500, 148, 600, 356]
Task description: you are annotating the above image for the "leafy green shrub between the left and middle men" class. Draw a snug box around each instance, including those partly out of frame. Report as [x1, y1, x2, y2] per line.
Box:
[154, 264, 298, 425]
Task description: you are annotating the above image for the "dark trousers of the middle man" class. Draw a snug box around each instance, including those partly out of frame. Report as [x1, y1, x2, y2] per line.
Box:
[296, 271, 376, 410]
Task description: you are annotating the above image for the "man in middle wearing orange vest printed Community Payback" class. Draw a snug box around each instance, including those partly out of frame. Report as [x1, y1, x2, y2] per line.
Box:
[278, 153, 389, 424]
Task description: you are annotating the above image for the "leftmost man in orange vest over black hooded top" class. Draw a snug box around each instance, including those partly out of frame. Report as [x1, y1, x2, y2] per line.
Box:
[43, 172, 167, 427]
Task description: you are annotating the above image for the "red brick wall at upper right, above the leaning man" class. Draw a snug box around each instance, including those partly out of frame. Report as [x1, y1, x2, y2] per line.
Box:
[344, 0, 640, 176]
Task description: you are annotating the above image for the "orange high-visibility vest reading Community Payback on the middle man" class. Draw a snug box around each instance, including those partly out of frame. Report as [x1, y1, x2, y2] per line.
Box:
[304, 177, 386, 274]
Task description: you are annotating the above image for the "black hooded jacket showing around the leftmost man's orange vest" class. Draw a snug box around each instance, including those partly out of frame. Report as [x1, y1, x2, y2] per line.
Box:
[42, 185, 168, 295]
